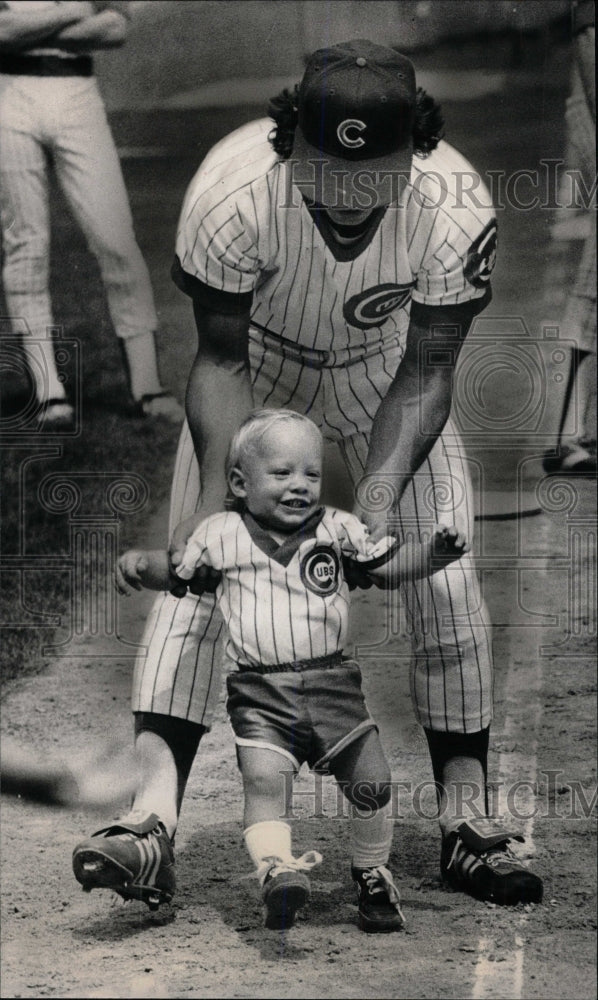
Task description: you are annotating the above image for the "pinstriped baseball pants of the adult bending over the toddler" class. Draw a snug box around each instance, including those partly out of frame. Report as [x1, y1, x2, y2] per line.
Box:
[132, 330, 492, 733]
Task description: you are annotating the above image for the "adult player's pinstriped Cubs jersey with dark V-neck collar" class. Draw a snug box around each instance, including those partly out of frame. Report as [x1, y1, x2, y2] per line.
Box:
[173, 119, 496, 365]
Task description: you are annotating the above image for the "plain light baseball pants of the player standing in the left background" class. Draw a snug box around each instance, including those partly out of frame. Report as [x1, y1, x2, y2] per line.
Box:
[0, 74, 157, 399]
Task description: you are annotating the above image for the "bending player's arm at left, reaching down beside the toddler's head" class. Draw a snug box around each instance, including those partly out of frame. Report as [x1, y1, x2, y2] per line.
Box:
[170, 297, 253, 568]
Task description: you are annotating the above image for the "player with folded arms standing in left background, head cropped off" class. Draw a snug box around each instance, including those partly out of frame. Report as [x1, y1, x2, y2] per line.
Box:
[0, 0, 183, 427]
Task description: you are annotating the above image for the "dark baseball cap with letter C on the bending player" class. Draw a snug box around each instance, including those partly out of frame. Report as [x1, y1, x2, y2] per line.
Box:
[292, 39, 416, 208]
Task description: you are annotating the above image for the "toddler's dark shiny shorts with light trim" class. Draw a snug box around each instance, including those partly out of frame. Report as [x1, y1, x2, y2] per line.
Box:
[226, 656, 378, 773]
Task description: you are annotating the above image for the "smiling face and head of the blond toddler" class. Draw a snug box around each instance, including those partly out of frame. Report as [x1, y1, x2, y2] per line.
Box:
[231, 423, 322, 532]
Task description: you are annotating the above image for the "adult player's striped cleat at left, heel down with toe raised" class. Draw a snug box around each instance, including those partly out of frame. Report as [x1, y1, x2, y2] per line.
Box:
[73, 812, 175, 910]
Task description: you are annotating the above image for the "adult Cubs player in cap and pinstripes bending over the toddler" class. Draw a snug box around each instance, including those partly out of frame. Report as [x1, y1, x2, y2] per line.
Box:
[72, 40, 542, 916]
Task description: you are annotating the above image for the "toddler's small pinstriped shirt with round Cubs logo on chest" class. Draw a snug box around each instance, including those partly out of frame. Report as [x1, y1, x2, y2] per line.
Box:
[176, 507, 394, 665]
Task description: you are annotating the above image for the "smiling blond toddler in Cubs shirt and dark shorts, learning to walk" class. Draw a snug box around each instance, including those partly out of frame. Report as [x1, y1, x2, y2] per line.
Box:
[74, 409, 466, 932]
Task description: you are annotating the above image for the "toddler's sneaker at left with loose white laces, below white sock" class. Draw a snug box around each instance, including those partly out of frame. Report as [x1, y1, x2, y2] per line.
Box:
[257, 851, 322, 931]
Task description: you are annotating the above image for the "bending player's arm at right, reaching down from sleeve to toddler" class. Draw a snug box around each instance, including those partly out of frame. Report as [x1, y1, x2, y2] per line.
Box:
[356, 299, 480, 539]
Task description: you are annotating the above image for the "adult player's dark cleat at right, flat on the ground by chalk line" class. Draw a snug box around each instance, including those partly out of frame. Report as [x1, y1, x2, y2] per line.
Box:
[440, 818, 543, 906]
